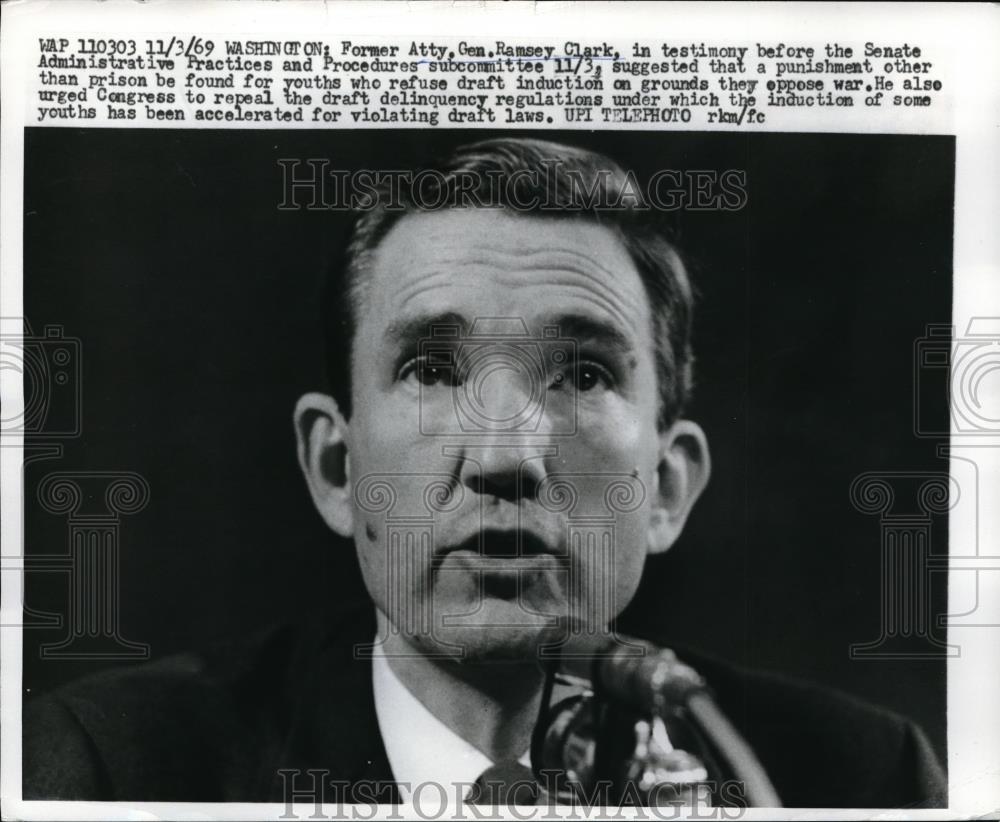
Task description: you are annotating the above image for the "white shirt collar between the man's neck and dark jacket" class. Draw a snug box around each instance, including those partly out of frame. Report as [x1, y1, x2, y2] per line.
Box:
[372, 644, 531, 802]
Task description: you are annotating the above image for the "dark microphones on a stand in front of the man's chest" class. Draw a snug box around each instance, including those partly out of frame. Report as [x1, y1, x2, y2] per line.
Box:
[531, 630, 781, 808]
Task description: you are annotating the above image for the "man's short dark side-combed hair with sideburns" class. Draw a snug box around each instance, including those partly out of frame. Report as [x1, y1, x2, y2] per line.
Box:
[322, 137, 694, 428]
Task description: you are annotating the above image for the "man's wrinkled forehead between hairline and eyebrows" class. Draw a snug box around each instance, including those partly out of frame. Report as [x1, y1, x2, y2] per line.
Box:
[359, 209, 651, 347]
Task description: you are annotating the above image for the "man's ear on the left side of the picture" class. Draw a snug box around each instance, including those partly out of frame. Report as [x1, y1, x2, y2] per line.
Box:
[295, 394, 354, 537]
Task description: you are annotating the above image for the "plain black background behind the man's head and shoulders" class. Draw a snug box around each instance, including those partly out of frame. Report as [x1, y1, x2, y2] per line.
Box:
[24, 128, 954, 756]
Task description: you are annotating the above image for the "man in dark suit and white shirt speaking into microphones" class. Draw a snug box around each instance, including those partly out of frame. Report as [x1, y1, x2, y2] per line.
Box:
[24, 139, 945, 807]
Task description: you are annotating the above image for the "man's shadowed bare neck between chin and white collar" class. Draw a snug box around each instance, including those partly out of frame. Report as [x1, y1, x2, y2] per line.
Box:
[377, 612, 544, 762]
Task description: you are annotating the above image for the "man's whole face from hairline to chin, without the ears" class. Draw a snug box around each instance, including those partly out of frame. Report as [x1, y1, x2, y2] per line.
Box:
[345, 210, 672, 659]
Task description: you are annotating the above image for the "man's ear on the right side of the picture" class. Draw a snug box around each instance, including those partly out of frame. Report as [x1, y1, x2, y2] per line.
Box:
[648, 420, 712, 554]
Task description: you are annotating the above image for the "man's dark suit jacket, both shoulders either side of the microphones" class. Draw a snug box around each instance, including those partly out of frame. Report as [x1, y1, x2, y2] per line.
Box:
[23, 612, 947, 807]
